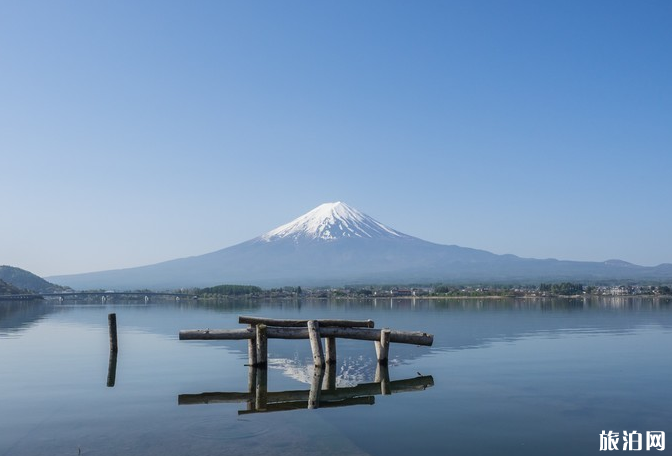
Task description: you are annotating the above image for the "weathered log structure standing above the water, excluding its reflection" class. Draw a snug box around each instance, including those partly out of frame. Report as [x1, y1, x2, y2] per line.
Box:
[180, 316, 434, 367]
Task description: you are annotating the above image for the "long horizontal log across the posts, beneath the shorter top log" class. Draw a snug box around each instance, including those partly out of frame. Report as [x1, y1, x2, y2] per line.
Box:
[180, 327, 434, 346]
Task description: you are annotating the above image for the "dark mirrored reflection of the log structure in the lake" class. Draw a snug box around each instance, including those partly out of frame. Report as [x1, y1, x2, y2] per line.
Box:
[177, 364, 434, 415]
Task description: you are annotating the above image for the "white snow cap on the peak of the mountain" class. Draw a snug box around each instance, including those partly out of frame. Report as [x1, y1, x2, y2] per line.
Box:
[261, 201, 409, 242]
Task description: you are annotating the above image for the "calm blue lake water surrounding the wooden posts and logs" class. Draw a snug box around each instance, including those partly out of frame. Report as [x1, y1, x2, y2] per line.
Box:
[0, 299, 672, 456]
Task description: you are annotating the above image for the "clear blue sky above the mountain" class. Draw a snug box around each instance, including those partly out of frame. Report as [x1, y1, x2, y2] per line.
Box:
[0, 0, 672, 276]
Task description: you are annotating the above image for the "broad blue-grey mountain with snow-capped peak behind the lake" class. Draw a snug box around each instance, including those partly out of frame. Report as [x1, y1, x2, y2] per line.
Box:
[50, 202, 672, 290]
